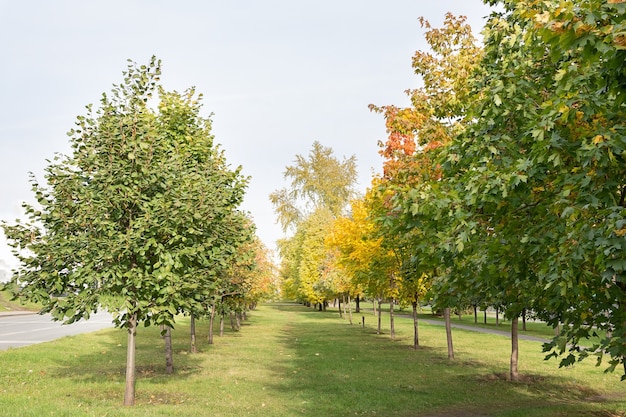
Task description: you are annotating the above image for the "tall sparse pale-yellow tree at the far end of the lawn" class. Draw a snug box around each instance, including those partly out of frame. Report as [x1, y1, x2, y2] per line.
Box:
[270, 142, 356, 308]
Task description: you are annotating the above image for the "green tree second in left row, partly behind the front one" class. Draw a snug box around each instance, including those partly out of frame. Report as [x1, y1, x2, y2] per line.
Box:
[158, 88, 254, 373]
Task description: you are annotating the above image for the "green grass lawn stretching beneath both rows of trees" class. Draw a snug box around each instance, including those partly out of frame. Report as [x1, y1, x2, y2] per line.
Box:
[0, 303, 626, 417]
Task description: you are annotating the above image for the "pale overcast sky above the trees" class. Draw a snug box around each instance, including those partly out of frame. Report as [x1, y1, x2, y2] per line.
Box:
[0, 0, 489, 267]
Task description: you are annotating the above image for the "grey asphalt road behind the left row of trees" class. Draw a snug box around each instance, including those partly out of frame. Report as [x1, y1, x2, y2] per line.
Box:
[0, 312, 113, 350]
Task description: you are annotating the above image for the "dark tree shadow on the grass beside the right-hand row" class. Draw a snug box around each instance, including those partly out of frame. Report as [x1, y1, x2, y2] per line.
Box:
[264, 304, 623, 417]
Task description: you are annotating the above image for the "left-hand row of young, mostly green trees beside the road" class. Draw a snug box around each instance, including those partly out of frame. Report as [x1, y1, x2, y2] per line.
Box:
[2, 57, 275, 405]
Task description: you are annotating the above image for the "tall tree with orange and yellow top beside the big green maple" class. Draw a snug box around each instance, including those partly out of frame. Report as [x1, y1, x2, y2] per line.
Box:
[370, 14, 482, 357]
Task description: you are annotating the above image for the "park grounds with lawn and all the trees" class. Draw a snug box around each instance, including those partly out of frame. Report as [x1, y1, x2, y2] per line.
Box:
[0, 0, 626, 417]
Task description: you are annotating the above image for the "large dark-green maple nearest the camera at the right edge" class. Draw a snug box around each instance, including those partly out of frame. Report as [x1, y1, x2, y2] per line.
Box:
[444, 0, 626, 378]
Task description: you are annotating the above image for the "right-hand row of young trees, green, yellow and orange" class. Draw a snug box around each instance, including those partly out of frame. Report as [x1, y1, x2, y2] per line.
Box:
[274, 0, 626, 379]
